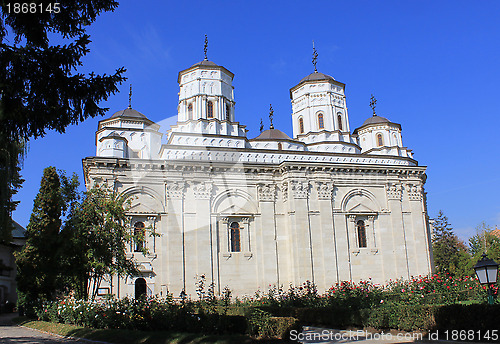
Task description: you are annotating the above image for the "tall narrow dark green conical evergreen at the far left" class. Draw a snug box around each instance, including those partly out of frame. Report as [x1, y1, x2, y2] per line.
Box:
[16, 167, 64, 314]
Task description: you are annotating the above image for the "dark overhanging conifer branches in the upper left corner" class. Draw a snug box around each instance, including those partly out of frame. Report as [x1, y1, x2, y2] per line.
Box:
[0, 0, 125, 242]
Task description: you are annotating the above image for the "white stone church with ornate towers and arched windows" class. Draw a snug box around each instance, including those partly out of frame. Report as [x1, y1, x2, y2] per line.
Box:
[83, 53, 432, 297]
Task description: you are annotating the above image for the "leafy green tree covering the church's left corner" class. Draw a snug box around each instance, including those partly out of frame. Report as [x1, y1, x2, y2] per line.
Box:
[63, 186, 141, 299]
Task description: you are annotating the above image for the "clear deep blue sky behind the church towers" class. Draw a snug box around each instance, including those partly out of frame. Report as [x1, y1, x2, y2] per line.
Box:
[13, 0, 500, 239]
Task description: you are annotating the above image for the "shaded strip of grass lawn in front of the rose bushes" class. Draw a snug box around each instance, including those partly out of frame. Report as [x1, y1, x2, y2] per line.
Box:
[14, 317, 284, 344]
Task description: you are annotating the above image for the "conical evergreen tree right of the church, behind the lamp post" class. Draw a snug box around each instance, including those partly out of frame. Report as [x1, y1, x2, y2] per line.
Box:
[432, 210, 470, 276]
